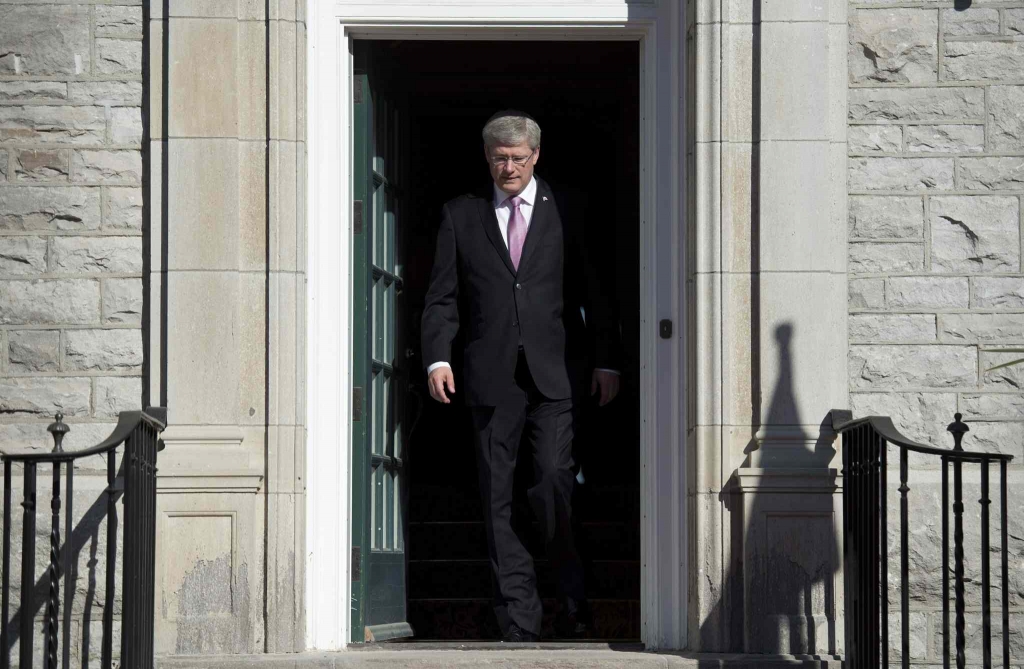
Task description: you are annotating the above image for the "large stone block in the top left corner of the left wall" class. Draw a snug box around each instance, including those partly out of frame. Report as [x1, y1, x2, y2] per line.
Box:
[0, 5, 90, 77]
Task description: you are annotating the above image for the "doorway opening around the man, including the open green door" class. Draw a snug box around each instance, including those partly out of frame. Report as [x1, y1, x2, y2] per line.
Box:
[351, 40, 641, 641]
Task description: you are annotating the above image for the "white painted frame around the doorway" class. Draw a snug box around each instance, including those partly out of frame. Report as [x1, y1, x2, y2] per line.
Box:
[305, 0, 688, 650]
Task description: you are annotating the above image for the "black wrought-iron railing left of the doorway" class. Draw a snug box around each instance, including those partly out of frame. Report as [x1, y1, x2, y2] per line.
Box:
[0, 408, 166, 669]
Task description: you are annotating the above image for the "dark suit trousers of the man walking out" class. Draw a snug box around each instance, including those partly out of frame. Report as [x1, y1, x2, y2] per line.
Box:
[471, 351, 585, 634]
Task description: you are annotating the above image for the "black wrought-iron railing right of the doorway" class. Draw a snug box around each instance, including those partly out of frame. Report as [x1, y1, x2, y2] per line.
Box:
[831, 410, 1013, 669]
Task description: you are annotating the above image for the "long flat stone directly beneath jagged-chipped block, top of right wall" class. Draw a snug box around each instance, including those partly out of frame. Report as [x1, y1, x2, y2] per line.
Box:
[848, 88, 985, 121]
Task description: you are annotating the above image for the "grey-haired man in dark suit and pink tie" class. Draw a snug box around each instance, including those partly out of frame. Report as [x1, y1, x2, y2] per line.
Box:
[422, 111, 618, 641]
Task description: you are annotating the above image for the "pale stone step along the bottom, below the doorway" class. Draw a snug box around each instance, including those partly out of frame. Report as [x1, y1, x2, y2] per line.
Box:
[157, 642, 842, 669]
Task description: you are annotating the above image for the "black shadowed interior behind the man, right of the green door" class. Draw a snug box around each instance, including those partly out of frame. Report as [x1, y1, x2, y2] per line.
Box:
[371, 41, 640, 640]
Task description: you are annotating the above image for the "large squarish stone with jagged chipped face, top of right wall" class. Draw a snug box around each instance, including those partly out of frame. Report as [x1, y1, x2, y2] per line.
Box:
[849, 9, 939, 83]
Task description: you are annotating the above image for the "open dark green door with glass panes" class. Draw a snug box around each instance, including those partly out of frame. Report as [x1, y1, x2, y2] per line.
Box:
[351, 41, 413, 642]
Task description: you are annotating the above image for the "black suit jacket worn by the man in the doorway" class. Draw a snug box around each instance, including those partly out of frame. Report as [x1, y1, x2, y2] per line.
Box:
[422, 175, 621, 406]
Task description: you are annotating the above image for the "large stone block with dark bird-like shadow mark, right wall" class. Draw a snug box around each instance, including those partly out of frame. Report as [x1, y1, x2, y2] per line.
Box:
[929, 196, 1020, 271]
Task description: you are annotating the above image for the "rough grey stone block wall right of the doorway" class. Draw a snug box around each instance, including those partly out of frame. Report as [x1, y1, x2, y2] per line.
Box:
[848, 0, 1024, 662]
